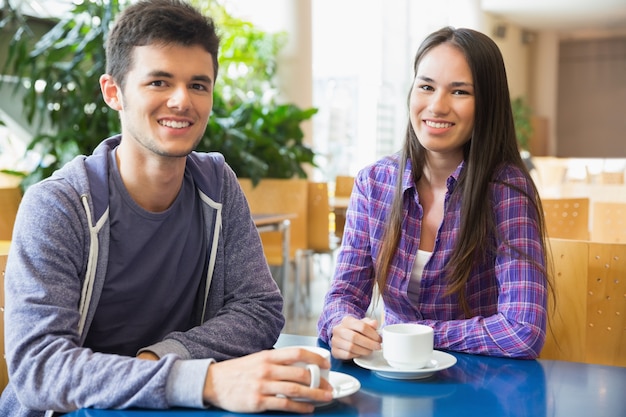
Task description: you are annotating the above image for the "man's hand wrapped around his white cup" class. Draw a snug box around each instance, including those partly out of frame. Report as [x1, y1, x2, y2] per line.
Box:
[203, 347, 333, 413]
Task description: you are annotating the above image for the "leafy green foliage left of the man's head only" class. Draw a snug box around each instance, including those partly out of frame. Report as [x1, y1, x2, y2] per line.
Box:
[3, 0, 123, 187]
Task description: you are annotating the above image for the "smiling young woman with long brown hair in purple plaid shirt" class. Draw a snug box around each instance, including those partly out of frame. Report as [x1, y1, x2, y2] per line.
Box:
[318, 27, 549, 359]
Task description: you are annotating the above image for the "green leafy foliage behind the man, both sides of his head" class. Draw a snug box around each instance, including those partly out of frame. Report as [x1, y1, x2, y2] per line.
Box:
[0, 0, 317, 187]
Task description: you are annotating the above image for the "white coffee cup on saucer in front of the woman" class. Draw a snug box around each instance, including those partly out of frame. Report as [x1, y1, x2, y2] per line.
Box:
[382, 323, 435, 370]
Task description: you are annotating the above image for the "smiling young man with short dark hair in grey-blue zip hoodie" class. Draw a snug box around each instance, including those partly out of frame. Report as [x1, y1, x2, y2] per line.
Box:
[0, 0, 332, 416]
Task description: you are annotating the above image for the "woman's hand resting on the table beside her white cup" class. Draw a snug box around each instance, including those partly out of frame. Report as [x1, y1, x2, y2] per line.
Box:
[330, 316, 383, 360]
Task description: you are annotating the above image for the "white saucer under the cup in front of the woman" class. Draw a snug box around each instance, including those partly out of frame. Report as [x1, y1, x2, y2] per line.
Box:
[354, 350, 456, 379]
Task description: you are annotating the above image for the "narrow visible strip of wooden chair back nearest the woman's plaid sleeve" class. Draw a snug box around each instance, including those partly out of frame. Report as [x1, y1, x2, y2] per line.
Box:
[307, 182, 330, 252]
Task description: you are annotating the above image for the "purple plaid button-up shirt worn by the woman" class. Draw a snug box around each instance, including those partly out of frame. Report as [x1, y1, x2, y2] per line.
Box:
[318, 155, 547, 358]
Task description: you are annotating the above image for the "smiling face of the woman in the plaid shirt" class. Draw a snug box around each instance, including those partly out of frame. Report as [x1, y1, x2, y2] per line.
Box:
[409, 43, 475, 162]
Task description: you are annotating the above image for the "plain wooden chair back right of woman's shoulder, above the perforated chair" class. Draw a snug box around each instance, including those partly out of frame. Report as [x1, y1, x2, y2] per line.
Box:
[541, 198, 589, 240]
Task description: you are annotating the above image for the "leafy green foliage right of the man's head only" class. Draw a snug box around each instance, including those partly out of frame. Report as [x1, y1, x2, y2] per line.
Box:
[195, 0, 317, 184]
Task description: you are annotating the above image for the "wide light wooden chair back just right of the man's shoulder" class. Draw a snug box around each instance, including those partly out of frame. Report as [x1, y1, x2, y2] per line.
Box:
[239, 178, 308, 265]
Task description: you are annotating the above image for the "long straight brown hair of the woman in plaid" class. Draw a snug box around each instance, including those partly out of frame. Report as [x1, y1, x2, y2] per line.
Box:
[376, 27, 549, 317]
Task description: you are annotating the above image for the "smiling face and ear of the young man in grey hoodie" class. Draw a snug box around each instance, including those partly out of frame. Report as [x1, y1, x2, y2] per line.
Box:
[103, 44, 215, 157]
